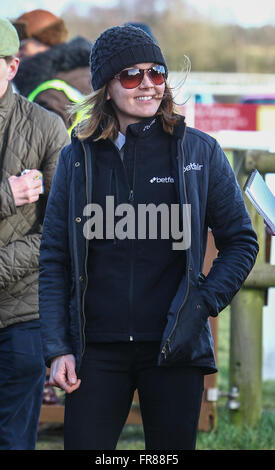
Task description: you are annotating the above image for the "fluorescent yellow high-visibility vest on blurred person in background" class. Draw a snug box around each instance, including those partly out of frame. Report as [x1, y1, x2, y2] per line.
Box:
[28, 79, 83, 135]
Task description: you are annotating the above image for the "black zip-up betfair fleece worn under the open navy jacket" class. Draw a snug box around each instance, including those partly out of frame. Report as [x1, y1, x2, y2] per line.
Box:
[85, 119, 185, 341]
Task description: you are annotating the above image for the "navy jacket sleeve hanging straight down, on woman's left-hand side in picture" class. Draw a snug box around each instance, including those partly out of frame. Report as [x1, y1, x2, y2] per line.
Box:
[39, 148, 72, 366]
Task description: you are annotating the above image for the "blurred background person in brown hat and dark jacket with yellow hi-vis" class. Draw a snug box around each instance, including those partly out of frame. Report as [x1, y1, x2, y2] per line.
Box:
[13, 9, 91, 133]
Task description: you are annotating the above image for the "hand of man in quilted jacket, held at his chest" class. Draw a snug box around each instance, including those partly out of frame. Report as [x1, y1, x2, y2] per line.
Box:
[9, 170, 42, 206]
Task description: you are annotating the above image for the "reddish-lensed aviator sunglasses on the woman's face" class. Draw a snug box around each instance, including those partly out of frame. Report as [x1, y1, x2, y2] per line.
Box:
[114, 65, 166, 90]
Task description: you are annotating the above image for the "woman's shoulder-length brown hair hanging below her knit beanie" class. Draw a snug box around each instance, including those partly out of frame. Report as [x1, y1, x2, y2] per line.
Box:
[70, 83, 180, 141]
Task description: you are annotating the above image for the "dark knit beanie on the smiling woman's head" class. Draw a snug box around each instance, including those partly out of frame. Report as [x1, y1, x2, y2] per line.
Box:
[90, 26, 168, 90]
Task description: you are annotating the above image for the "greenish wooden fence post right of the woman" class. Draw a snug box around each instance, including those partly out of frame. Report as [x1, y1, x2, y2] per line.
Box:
[229, 152, 265, 426]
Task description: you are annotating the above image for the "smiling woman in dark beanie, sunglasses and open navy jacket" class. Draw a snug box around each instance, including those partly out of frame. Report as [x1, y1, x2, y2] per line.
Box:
[40, 26, 258, 449]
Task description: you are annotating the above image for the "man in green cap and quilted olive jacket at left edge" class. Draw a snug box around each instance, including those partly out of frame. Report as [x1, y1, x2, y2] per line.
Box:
[0, 18, 69, 450]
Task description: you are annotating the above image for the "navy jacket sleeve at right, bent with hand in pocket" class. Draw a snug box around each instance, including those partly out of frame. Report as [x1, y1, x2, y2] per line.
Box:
[201, 143, 259, 316]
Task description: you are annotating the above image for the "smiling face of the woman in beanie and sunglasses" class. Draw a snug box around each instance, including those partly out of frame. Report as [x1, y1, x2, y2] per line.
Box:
[107, 63, 165, 134]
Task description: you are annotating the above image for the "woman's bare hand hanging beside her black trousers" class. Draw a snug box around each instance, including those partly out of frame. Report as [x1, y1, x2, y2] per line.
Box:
[49, 354, 81, 393]
